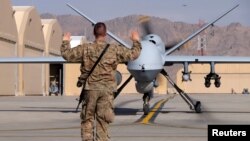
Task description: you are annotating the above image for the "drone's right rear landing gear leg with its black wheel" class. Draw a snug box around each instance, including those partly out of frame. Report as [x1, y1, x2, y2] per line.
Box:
[161, 70, 201, 113]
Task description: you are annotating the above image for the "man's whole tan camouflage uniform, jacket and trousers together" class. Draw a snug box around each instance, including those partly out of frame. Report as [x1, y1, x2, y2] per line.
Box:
[61, 41, 141, 141]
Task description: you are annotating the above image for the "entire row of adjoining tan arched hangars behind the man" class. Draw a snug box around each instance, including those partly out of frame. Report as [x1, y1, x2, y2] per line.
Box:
[0, 0, 62, 96]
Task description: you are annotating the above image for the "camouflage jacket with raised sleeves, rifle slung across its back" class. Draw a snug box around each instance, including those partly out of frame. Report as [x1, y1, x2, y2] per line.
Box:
[61, 41, 141, 91]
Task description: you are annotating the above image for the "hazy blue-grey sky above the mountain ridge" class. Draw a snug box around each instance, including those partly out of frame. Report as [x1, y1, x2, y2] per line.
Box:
[11, 0, 250, 26]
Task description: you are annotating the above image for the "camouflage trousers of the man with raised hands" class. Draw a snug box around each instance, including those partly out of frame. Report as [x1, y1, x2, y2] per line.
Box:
[81, 90, 114, 141]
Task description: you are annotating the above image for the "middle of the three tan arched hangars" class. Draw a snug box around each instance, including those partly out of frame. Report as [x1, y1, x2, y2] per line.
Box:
[13, 6, 45, 95]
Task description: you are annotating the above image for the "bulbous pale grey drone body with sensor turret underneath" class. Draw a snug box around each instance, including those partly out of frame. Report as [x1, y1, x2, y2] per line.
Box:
[127, 34, 165, 93]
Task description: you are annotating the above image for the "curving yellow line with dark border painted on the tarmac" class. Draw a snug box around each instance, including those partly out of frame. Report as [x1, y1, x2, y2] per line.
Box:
[138, 95, 175, 124]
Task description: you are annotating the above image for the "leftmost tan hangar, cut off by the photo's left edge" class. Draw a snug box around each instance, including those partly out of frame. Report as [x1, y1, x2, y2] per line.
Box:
[0, 0, 18, 95]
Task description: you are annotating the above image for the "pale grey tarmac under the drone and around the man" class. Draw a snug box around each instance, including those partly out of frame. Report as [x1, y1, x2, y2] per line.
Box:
[0, 94, 250, 141]
